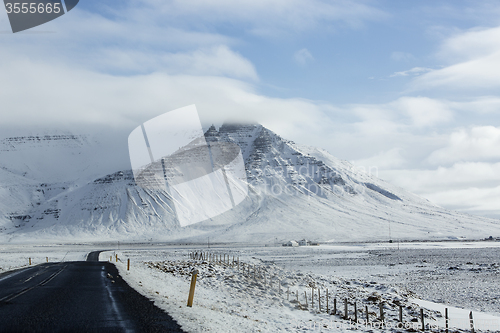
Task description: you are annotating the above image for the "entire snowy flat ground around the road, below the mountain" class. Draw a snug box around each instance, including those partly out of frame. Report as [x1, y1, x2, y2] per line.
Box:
[0, 242, 500, 332]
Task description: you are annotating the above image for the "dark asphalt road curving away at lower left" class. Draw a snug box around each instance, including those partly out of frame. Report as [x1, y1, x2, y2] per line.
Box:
[0, 252, 183, 332]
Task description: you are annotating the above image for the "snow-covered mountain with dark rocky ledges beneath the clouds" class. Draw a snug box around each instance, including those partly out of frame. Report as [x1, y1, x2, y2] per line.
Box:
[0, 124, 500, 243]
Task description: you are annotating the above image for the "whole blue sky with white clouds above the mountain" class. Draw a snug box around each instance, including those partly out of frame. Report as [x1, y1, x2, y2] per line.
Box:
[0, 0, 500, 218]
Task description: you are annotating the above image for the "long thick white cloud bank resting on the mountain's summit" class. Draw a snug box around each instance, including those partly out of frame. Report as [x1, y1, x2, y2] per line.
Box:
[0, 51, 330, 141]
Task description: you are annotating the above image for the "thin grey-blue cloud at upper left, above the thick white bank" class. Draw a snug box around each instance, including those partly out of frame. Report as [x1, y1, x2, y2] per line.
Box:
[0, 7, 238, 79]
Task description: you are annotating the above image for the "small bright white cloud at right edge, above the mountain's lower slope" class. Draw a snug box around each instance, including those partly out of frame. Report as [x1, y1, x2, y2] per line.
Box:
[427, 126, 500, 164]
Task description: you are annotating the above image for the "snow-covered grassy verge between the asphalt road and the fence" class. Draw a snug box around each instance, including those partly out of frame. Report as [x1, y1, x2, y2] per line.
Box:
[100, 250, 474, 332]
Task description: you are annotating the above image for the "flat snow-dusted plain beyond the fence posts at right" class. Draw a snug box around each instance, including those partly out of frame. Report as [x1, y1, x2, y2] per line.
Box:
[264, 242, 500, 316]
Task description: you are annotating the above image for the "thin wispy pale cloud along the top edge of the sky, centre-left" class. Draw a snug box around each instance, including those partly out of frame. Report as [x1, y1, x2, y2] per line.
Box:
[133, 0, 387, 37]
